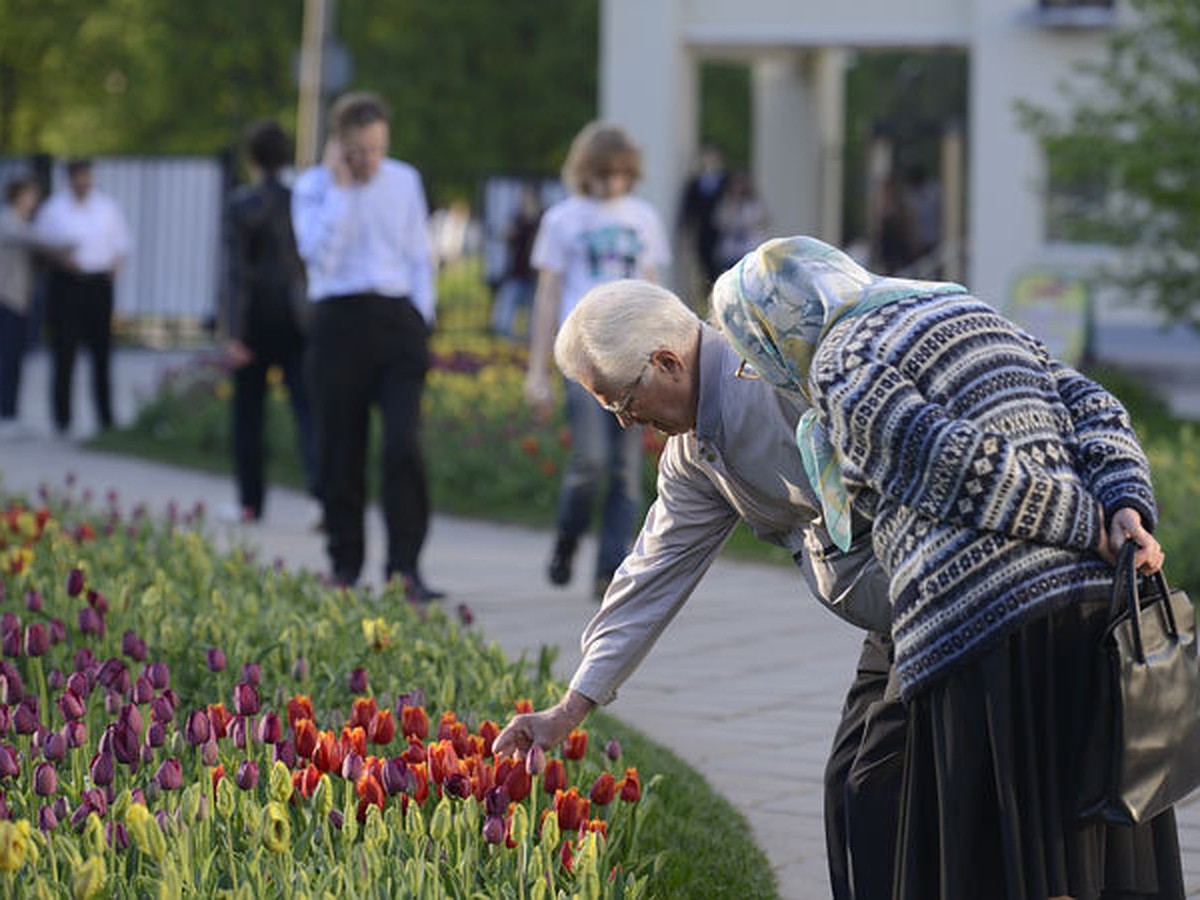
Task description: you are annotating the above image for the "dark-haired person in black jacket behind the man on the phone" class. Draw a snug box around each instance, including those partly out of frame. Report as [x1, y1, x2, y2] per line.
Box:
[227, 120, 318, 522]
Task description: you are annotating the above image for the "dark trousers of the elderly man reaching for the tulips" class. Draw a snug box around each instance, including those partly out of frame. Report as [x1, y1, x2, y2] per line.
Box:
[824, 632, 908, 900]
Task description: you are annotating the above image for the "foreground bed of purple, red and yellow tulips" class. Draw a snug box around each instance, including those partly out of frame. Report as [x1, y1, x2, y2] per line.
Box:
[0, 497, 660, 898]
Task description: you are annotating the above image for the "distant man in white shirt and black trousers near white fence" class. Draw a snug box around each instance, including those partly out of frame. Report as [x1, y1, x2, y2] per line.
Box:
[35, 160, 132, 437]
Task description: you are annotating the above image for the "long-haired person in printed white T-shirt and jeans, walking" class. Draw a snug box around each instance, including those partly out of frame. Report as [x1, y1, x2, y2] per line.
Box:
[526, 122, 671, 600]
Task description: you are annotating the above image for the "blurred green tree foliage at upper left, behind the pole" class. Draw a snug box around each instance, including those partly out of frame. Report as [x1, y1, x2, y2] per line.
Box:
[0, 0, 598, 197]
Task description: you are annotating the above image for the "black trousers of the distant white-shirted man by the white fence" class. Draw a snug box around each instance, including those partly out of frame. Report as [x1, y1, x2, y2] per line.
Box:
[46, 270, 113, 432]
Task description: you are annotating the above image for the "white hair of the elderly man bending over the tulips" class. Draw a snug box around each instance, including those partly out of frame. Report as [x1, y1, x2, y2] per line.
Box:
[554, 278, 700, 389]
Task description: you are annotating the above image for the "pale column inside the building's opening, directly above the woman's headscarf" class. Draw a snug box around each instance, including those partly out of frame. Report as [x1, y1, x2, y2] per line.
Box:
[751, 52, 822, 235]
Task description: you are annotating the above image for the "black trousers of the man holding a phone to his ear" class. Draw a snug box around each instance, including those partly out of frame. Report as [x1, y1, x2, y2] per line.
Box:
[308, 294, 430, 584]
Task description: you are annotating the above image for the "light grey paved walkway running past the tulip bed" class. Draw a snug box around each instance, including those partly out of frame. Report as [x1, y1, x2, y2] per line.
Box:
[0, 352, 1200, 900]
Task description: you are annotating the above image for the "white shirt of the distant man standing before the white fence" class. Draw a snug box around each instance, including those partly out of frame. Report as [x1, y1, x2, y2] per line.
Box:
[34, 188, 133, 275]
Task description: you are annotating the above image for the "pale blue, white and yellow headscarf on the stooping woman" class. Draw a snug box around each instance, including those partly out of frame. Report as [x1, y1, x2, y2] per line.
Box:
[713, 236, 967, 550]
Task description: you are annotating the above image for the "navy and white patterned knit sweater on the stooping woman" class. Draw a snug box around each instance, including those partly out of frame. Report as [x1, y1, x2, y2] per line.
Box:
[810, 295, 1156, 700]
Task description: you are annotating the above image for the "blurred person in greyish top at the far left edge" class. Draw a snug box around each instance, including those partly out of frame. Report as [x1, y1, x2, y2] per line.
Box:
[0, 175, 73, 438]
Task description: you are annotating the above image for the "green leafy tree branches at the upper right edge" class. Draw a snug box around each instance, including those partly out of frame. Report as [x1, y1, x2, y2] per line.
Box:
[1022, 0, 1200, 329]
